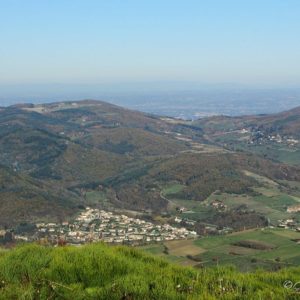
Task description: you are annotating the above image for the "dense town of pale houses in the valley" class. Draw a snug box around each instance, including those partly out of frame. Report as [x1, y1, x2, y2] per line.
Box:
[4, 207, 197, 245]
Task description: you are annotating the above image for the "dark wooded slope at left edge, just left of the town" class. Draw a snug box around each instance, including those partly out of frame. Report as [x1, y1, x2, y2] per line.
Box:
[0, 166, 80, 227]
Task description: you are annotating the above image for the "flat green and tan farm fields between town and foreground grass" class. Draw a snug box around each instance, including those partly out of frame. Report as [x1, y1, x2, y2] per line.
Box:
[142, 228, 300, 272]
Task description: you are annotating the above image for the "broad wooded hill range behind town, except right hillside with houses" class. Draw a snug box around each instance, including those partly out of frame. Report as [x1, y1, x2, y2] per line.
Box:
[0, 100, 300, 225]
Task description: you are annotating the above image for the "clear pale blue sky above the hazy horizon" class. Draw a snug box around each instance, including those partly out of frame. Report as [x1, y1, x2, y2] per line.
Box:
[0, 0, 300, 86]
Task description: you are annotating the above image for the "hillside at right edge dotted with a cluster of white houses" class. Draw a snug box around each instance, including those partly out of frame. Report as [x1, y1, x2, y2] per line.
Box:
[193, 107, 300, 165]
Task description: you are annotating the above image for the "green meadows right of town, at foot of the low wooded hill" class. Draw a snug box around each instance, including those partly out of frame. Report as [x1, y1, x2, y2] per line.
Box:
[162, 171, 300, 225]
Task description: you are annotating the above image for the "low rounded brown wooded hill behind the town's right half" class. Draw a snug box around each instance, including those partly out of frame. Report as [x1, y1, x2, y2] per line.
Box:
[105, 153, 300, 211]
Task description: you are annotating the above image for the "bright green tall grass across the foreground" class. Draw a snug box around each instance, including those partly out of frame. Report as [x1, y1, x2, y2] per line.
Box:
[0, 244, 300, 299]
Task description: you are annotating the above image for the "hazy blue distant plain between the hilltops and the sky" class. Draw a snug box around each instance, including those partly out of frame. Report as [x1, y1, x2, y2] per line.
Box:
[0, 82, 300, 119]
